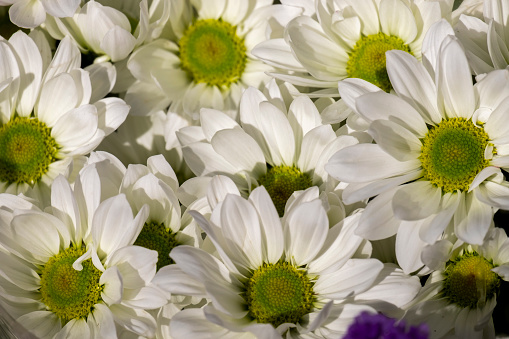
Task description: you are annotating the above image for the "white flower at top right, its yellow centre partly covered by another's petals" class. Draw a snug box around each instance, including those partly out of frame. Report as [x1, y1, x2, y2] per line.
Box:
[253, 0, 452, 96]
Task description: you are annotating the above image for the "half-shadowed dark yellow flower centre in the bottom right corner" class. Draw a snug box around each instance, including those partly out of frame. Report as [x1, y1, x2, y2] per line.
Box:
[442, 252, 500, 308]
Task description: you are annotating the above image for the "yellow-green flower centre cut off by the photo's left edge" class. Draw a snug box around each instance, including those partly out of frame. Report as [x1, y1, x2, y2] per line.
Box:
[0, 117, 58, 184]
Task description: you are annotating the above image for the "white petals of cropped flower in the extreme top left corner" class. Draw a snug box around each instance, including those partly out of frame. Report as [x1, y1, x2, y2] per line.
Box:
[0, 0, 81, 28]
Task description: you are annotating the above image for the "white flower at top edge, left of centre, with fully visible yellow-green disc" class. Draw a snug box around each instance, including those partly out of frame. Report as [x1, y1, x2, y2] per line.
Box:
[125, 0, 301, 122]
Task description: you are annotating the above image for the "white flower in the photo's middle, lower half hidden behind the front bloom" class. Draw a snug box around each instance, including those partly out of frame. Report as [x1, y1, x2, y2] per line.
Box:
[177, 87, 358, 216]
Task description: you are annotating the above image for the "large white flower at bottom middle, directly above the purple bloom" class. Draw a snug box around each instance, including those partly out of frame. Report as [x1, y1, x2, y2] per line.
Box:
[161, 187, 420, 339]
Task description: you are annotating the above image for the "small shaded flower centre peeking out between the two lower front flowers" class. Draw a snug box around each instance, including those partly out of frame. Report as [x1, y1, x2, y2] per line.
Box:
[134, 222, 180, 270]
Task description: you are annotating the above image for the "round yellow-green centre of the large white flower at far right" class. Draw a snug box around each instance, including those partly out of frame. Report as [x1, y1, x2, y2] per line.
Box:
[419, 118, 489, 192]
